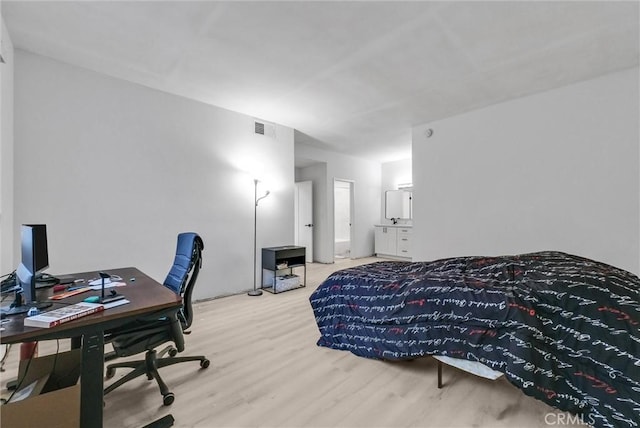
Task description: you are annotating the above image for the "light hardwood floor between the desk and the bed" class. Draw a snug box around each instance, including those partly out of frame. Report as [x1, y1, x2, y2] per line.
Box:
[2, 258, 566, 428]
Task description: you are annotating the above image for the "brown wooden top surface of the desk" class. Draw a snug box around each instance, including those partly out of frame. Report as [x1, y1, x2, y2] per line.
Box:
[0, 267, 182, 344]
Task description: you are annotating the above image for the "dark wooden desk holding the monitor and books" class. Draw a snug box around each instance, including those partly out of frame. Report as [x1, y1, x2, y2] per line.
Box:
[0, 267, 182, 428]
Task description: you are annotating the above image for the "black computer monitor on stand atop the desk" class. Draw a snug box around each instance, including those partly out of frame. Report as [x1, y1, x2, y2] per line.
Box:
[9, 224, 51, 314]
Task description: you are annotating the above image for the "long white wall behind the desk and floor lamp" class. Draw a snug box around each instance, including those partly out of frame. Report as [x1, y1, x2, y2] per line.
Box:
[14, 50, 294, 299]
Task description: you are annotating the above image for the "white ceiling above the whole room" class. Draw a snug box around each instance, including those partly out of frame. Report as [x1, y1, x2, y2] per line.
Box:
[1, 0, 640, 162]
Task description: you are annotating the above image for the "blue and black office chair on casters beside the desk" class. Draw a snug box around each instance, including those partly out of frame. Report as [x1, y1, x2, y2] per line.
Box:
[104, 233, 209, 406]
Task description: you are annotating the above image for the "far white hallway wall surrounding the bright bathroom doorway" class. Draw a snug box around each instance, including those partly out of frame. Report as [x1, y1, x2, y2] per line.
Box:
[295, 143, 380, 263]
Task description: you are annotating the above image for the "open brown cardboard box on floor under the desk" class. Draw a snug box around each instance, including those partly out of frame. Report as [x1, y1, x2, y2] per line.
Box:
[0, 349, 81, 428]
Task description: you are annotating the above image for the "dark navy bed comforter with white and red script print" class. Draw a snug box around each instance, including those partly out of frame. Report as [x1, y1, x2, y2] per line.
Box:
[310, 252, 640, 428]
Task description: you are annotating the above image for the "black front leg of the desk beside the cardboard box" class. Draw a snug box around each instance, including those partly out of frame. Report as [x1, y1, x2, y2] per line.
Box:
[80, 332, 104, 428]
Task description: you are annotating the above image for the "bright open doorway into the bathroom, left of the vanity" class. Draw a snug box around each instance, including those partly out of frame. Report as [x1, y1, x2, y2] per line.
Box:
[333, 179, 354, 259]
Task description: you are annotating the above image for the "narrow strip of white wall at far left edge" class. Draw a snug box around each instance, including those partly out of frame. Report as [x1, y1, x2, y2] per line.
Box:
[0, 13, 15, 275]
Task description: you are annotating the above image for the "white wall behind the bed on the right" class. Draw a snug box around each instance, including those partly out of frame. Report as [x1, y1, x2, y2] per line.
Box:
[413, 68, 640, 274]
